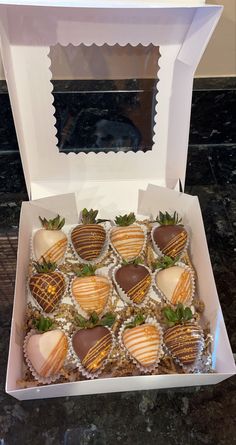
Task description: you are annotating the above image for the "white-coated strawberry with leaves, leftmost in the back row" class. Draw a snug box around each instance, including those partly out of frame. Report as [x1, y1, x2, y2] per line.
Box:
[33, 215, 68, 264]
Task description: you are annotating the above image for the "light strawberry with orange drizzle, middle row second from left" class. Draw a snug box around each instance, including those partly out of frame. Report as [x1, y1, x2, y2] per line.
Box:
[71, 265, 111, 314]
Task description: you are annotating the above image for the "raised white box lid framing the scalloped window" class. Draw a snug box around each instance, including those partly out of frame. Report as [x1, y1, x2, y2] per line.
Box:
[0, 0, 222, 198]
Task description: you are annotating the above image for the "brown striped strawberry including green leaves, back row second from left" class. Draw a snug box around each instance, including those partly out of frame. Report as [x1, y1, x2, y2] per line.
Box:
[71, 209, 106, 262]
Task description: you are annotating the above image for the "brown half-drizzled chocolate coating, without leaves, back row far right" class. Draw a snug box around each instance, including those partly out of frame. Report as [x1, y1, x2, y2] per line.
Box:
[153, 225, 187, 257]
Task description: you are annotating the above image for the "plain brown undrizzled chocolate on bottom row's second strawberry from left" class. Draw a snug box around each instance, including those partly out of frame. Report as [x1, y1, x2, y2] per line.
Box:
[72, 326, 112, 362]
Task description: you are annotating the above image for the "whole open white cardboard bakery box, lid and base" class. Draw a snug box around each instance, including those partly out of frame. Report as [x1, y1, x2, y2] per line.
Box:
[0, 0, 235, 400]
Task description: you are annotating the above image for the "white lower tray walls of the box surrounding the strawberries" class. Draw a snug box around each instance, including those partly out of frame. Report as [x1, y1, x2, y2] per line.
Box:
[6, 185, 235, 399]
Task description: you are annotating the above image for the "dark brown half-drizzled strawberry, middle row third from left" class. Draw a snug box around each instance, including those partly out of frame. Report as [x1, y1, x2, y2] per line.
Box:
[114, 261, 152, 304]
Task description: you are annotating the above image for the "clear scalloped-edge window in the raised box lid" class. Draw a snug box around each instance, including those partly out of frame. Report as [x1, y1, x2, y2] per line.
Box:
[50, 45, 159, 153]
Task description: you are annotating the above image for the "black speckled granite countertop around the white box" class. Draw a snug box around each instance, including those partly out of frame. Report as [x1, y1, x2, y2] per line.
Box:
[0, 78, 236, 445]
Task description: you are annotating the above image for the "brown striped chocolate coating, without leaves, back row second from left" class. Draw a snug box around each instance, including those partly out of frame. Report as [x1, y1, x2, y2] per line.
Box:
[71, 224, 106, 261]
